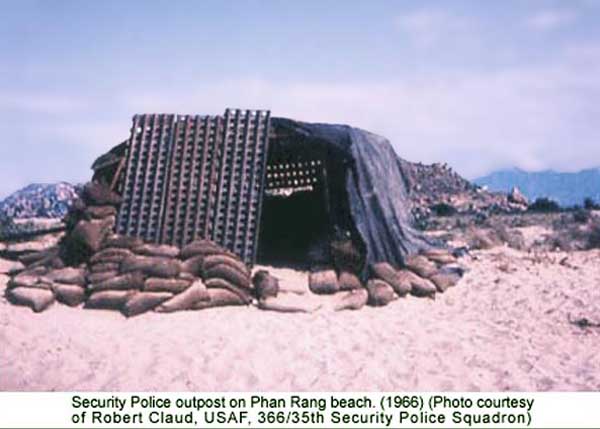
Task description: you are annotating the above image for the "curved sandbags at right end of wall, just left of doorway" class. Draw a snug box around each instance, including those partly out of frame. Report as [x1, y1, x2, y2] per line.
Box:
[180, 240, 254, 309]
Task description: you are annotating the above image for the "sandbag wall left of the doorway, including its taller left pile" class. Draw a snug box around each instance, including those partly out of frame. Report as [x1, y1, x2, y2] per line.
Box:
[6, 183, 254, 316]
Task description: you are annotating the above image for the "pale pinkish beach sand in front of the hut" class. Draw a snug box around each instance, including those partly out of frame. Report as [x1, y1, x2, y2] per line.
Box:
[0, 248, 600, 391]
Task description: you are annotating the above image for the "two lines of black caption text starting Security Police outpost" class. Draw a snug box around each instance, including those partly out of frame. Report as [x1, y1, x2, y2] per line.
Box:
[71, 394, 535, 428]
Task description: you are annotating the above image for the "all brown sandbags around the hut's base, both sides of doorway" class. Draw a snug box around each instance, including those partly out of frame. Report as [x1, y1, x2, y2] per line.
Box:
[6, 183, 462, 317]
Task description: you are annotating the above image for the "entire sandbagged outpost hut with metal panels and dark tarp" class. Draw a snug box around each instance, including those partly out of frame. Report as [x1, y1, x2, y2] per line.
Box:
[6, 110, 463, 317]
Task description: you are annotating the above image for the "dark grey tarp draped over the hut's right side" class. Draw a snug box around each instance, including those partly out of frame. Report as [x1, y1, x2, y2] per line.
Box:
[271, 118, 435, 266]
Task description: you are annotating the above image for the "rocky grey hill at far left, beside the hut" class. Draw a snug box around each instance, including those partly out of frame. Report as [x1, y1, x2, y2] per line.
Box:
[0, 182, 79, 219]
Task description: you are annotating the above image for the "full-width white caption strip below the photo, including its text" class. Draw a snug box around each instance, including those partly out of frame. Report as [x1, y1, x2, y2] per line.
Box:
[0, 393, 600, 428]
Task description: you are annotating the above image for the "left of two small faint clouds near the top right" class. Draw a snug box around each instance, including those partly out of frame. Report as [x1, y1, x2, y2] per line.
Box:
[395, 9, 474, 48]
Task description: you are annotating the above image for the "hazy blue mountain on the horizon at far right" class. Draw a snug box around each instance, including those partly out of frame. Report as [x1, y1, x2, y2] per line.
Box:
[474, 168, 600, 206]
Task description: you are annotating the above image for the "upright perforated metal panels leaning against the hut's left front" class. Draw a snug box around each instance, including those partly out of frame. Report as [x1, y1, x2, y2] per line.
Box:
[117, 109, 270, 264]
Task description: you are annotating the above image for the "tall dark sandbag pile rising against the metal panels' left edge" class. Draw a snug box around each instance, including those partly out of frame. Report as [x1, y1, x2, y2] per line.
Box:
[61, 182, 121, 265]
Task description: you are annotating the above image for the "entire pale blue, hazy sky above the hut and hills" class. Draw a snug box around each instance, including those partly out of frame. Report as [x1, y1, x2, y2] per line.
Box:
[0, 0, 600, 198]
